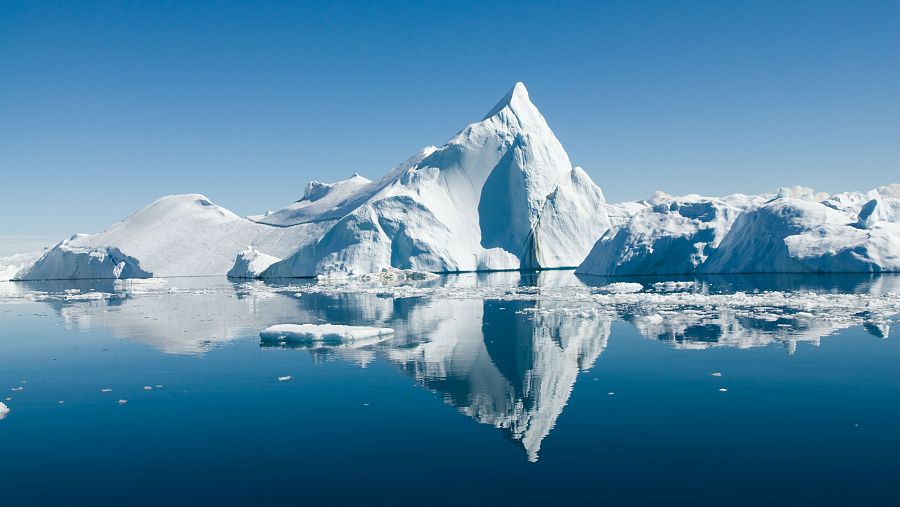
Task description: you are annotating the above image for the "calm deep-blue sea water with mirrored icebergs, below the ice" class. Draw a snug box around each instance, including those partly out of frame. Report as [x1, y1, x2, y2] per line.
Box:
[0, 271, 900, 507]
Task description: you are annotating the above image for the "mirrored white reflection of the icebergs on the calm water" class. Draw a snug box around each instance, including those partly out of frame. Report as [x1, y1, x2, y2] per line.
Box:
[0, 271, 900, 461]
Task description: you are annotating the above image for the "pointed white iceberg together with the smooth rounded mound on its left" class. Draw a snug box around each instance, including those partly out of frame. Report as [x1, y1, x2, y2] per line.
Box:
[14, 83, 610, 280]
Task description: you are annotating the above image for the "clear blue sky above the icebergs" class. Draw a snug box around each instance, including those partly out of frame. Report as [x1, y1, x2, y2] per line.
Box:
[0, 0, 900, 255]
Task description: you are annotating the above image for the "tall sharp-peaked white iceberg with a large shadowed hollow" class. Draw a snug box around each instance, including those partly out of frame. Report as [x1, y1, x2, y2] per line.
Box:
[263, 83, 609, 277]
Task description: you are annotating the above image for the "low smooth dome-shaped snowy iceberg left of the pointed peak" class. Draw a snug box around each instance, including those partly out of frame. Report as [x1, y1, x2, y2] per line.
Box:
[15, 194, 325, 280]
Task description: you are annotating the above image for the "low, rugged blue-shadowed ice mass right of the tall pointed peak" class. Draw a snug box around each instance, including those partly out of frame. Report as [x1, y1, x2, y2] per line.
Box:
[577, 184, 900, 275]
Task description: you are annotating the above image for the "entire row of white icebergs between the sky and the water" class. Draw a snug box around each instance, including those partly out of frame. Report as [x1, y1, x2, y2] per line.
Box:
[0, 83, 900, 280]
